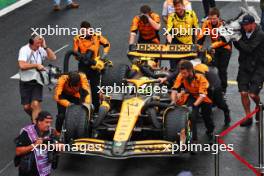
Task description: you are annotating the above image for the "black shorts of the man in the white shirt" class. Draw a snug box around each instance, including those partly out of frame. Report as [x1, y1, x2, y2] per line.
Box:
[19, 81, 43, 105]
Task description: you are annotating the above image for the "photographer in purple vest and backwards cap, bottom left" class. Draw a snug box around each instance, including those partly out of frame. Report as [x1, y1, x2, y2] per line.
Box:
[15, 111, 53, 176]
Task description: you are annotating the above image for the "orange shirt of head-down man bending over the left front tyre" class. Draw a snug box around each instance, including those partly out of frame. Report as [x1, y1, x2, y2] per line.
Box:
[54, 73, 91, 107]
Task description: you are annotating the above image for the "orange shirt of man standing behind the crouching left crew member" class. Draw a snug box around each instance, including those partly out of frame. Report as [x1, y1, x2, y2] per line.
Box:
[73, 35, 110, 58]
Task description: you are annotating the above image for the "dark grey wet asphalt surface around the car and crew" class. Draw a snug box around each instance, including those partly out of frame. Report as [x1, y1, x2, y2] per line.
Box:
[0, 0, 259, 176]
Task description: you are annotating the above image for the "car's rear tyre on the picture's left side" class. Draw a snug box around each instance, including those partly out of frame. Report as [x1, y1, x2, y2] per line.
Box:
[101, 64, 129, 86]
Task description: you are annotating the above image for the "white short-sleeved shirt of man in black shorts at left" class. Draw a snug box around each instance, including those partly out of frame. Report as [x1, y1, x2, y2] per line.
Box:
[18, 44, 47, 64]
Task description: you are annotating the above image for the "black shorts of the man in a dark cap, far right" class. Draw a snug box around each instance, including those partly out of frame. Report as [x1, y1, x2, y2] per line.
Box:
[237, 69, 263, 95]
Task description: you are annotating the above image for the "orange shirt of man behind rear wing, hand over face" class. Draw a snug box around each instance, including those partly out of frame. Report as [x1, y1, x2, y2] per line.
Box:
[130, 12, 160, 40]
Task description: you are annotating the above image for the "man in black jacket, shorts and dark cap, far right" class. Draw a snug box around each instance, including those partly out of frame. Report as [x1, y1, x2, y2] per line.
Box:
[234, 15, 264, 127]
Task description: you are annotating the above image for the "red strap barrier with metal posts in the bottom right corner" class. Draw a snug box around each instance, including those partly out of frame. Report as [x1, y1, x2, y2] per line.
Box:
[215, 104, 264, 176]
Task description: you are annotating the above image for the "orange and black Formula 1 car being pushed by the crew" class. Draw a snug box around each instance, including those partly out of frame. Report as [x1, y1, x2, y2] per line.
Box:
[56, 44, 216, 159]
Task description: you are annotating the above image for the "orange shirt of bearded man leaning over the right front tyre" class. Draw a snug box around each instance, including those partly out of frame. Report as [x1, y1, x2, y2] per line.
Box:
[173, 73, 212, 103]
